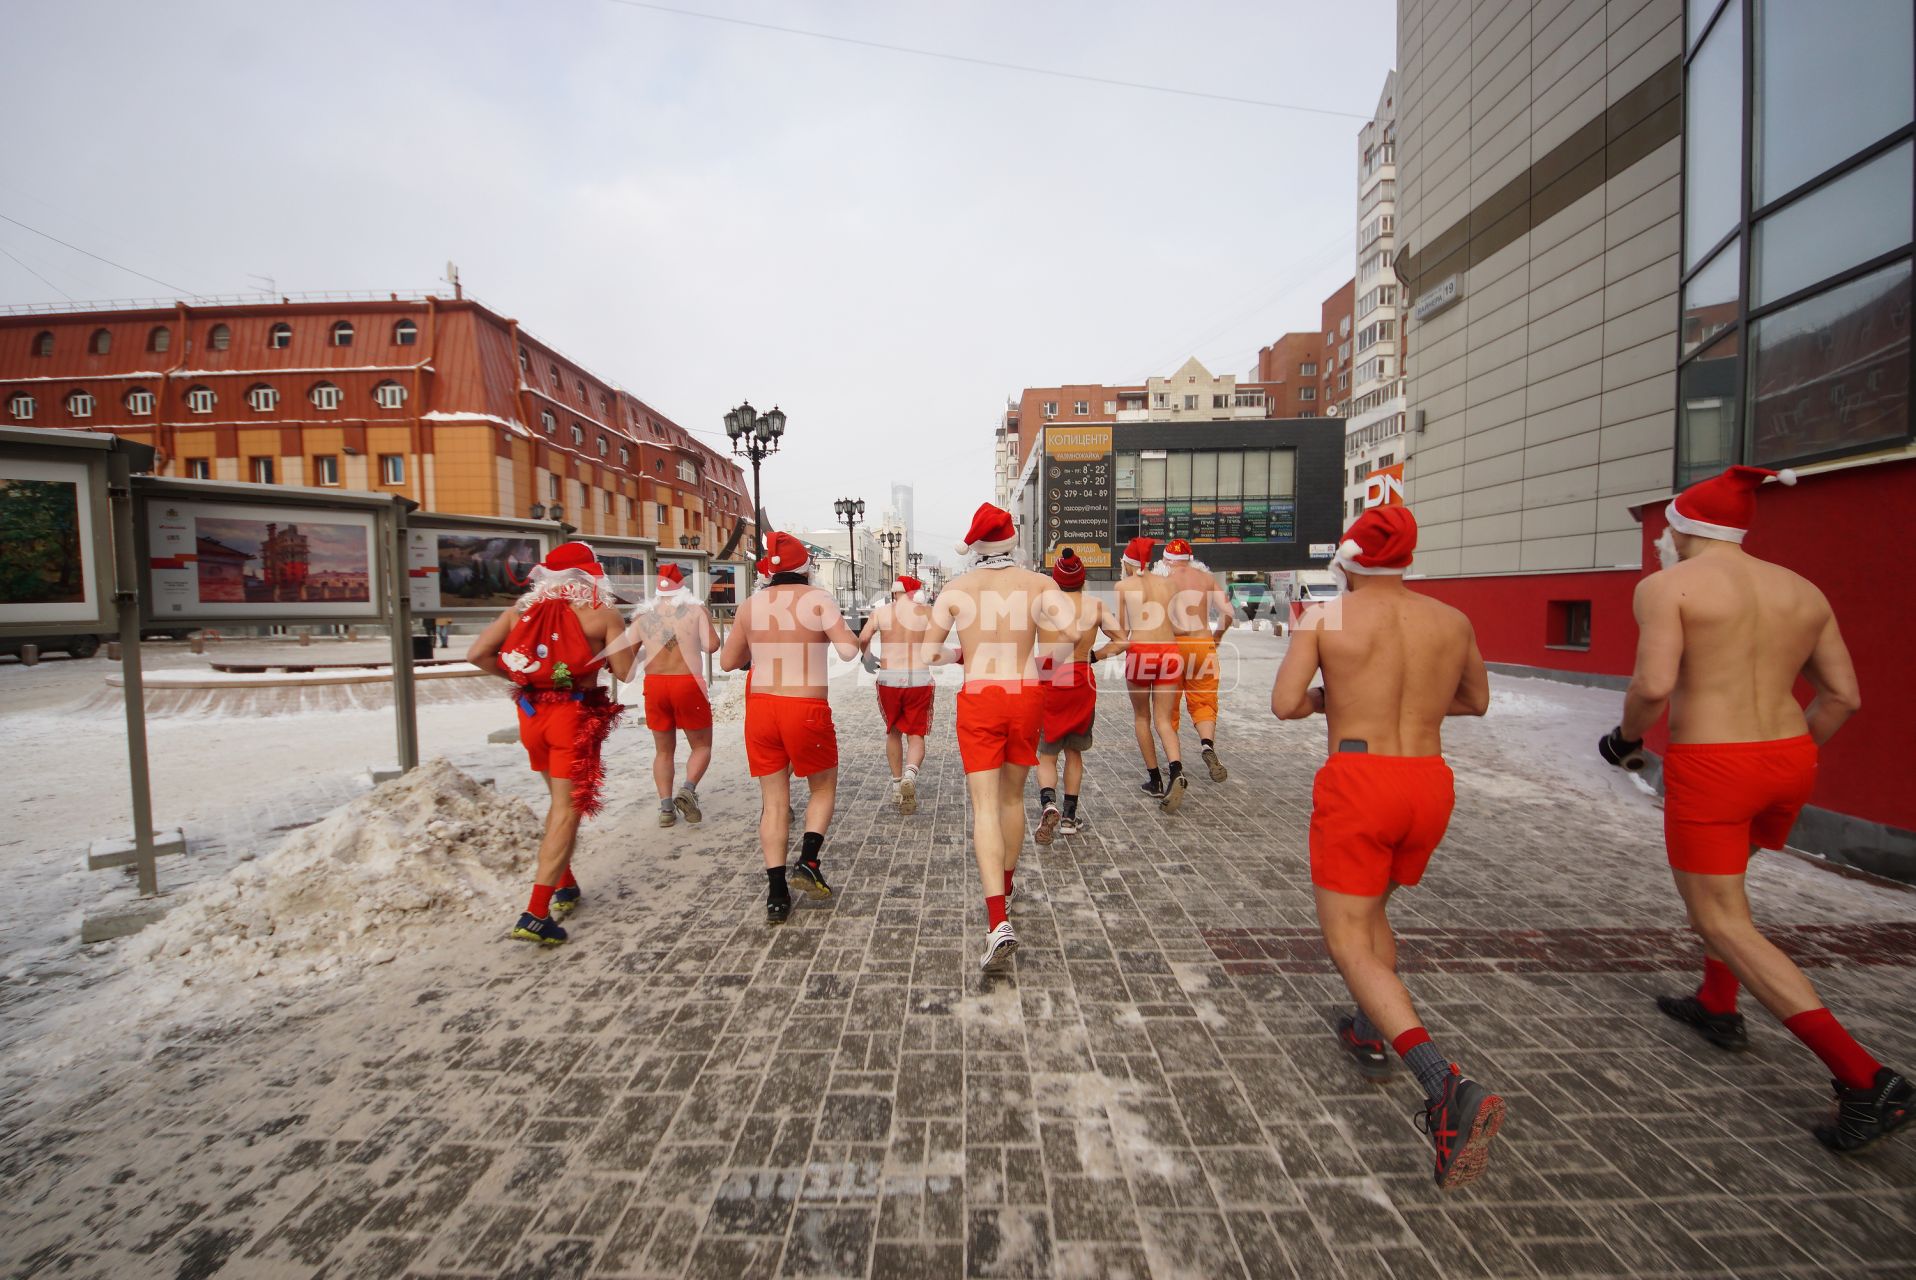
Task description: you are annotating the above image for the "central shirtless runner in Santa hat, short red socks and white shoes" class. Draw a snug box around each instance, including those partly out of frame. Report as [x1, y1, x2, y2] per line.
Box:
[924, 502, 1077, 970]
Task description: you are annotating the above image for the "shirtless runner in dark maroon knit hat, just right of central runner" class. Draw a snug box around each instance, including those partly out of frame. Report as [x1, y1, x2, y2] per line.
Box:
[1033, 546, 1125, 845]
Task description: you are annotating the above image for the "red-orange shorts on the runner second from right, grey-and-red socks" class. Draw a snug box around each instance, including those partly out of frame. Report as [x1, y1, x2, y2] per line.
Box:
[1311, 751, 1456, 899]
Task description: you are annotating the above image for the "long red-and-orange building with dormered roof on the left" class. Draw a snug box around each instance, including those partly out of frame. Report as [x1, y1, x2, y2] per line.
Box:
[0, 295, 751, 554]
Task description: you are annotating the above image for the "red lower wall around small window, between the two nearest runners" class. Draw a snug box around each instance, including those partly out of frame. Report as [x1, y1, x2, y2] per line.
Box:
[1410, 552, 1655, 676]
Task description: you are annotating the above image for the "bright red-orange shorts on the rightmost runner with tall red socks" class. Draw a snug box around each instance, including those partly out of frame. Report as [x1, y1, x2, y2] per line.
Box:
[1663, 734, 1816, 876]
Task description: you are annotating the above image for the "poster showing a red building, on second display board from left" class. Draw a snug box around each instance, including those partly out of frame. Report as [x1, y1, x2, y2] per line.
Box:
[146, 498, 381, 623]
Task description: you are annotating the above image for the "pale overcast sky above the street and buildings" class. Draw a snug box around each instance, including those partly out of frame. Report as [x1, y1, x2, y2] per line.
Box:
[0, 0, 1395, 556]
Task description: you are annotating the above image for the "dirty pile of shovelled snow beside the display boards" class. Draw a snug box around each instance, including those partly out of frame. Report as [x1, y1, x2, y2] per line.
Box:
[126, 759, 544, 987]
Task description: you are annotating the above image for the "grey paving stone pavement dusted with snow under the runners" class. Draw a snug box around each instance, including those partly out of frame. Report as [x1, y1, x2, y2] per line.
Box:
[0, 636, 1916, 1280]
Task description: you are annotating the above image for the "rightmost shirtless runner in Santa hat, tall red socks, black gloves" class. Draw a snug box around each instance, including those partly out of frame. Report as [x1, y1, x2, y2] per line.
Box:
[1598, 466, 1916, 1152]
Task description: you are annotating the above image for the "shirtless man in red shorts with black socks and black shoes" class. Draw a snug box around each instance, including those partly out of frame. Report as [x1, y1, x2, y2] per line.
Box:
[719, 533, 858, 924]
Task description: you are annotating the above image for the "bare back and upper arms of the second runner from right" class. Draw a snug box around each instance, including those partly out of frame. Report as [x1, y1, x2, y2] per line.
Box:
[1286, 581, 1483, 755]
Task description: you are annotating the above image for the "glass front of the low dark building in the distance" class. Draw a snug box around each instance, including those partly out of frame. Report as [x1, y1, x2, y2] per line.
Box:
[1113, 448, 1297, 544]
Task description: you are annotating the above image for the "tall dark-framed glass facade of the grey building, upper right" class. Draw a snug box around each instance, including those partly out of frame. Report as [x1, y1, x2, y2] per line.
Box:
[1677, 0, 1916, 485]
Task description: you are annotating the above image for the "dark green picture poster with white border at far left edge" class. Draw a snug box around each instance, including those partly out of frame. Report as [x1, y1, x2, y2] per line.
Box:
[0, 458, 102, 625]
